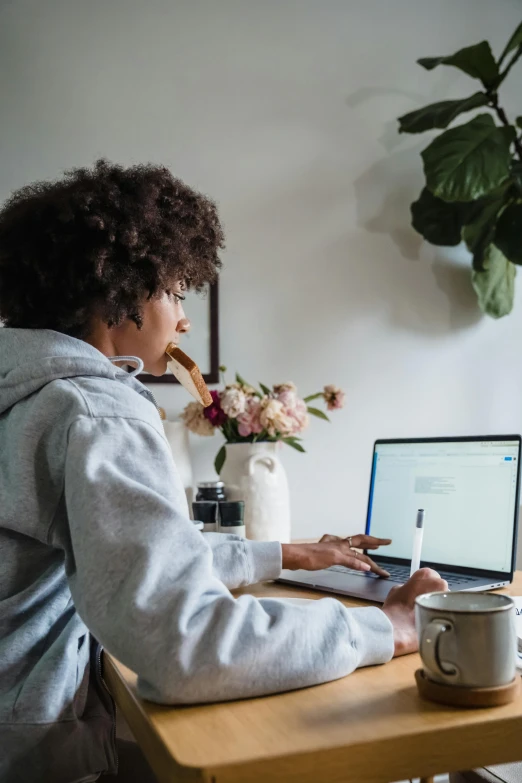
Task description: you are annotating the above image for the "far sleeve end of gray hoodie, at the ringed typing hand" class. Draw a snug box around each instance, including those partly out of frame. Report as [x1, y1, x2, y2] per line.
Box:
[203, 533, 283, 590]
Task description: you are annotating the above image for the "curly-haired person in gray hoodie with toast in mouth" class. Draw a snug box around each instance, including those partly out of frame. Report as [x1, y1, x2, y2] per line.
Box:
[0, 161, 445, 783]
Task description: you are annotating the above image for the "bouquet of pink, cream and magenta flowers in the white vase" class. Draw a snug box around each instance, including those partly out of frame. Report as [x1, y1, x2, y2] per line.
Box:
[181, 367, 345, 474]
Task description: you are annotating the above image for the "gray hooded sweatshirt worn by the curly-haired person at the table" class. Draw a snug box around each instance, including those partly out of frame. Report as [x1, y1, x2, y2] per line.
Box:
[0, 329, 393, 783]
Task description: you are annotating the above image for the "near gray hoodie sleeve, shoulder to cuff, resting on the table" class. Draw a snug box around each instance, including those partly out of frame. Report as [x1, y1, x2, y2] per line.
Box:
[65, 416, 393, 704]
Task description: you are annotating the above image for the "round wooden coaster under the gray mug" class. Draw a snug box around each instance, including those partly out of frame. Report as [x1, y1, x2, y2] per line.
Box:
[415, 669, 520, 707]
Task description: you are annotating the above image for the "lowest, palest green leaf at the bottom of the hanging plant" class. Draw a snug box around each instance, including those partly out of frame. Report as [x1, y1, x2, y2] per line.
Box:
[471, 245, 517, 318]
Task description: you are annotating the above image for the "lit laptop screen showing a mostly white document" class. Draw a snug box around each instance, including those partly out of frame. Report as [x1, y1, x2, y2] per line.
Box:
[366, 438, 520, 572]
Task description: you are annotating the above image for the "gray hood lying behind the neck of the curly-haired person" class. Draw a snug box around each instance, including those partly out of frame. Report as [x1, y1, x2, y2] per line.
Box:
[0, 328, 150, 414]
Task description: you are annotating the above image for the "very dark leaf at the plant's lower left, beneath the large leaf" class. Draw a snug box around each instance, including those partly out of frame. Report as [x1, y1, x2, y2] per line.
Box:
[411, 188, 470, 245]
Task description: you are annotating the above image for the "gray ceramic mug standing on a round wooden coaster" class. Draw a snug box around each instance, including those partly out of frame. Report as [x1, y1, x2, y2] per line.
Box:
[415, 592, 516, 688]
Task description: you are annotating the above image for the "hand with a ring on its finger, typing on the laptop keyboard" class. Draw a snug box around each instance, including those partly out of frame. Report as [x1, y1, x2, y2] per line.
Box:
[282, 535, 391, 578]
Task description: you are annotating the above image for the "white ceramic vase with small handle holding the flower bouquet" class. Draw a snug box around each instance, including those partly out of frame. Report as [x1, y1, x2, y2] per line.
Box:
[221, 443, 290, 543]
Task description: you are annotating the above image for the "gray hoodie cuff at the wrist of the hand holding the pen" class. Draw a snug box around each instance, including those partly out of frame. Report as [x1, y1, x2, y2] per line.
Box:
[345, 606, 395, 668]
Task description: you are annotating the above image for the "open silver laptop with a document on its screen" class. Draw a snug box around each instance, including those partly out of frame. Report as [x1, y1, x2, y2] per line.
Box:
[278, 435, 520, 603]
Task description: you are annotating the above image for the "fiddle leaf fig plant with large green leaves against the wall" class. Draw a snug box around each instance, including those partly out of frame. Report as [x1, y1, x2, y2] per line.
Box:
[399, 22, 522, 318]
